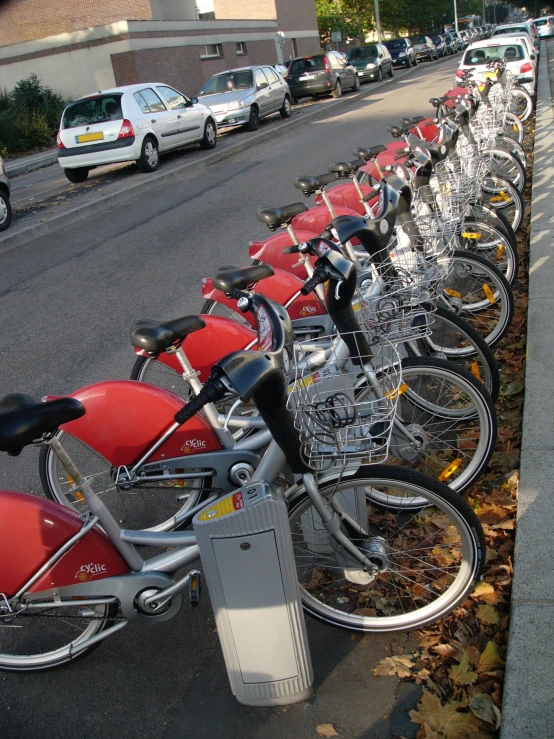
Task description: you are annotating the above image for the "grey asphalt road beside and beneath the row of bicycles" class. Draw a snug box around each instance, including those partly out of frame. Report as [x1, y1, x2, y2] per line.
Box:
[0, 58, 457, 739]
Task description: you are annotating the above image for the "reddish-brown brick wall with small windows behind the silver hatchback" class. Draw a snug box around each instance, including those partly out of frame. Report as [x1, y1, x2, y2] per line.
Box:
[111, 41, 275, 96]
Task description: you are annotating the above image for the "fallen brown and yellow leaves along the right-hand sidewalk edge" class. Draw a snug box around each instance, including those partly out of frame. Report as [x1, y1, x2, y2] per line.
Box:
[373, 118, 534, 739]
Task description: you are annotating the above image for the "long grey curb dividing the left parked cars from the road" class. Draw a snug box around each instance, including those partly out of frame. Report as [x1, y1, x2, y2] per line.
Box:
[0, 57, 450, 254]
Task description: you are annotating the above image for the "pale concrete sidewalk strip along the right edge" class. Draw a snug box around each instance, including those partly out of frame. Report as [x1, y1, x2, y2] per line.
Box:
[501, 40, 554, 739]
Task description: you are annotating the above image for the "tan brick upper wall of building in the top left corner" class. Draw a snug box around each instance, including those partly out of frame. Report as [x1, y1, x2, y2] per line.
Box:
[0, 0, 152, 46]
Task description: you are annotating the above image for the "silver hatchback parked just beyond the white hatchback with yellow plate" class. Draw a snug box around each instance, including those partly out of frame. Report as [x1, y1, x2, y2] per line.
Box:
[199, 65, 291, 131]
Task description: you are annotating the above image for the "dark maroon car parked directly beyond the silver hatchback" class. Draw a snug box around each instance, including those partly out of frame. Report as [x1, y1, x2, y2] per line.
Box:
[287, 51, 360, 102]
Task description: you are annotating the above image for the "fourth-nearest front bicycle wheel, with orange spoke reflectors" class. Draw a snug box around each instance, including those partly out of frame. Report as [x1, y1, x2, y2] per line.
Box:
[441, 251, 515, 348]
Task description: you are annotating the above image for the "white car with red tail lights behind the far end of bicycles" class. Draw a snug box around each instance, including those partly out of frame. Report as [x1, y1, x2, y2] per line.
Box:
[456, 36, 536, 95]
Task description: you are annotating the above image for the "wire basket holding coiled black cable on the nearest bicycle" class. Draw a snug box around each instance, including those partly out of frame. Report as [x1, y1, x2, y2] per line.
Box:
[287, 331, 402, 471]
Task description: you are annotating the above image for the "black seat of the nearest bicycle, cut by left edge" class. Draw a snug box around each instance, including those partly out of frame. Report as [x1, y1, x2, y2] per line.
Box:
[0, 394, 85, 457]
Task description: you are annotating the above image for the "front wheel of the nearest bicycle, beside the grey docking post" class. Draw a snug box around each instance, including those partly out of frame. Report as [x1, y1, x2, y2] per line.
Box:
[289, 465, 485, 632]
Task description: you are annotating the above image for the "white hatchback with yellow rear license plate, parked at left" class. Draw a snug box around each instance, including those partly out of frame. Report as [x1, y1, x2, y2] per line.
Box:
[57, 82, 217, 182]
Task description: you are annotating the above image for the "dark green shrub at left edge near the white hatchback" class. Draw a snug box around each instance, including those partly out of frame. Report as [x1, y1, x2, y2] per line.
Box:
[0, 74, 67, 154]
